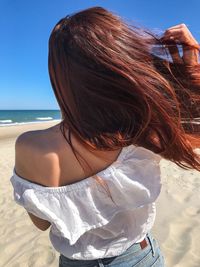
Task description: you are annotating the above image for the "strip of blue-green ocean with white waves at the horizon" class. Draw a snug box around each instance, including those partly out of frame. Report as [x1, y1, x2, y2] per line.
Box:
[0, 110, 61, 127]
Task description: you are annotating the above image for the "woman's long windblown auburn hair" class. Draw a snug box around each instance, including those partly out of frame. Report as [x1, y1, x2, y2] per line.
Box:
[48, 7, 200, 194]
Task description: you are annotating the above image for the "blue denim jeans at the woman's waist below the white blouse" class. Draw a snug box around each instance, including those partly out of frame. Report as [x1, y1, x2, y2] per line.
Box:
[59, 233, 165, 267]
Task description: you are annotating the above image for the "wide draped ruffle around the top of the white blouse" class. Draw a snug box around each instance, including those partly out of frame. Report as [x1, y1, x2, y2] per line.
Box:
[11, 146, 161, 245]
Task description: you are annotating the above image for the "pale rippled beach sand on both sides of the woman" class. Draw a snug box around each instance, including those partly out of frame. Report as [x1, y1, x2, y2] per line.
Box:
[0, 122, 200, 267]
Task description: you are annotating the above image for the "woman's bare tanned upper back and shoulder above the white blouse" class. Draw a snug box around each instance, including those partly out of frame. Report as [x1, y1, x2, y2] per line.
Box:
[15, 124, 121, 186]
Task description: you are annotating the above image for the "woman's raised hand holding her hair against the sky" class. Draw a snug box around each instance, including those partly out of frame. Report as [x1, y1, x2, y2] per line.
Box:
[160, 24, 200, 65]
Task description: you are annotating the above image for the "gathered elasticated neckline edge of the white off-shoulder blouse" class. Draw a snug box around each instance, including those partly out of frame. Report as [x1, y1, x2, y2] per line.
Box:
[13, 145, 135, 192]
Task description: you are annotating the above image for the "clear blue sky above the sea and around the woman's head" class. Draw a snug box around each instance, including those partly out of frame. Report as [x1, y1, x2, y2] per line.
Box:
[0, 0, 200, 109]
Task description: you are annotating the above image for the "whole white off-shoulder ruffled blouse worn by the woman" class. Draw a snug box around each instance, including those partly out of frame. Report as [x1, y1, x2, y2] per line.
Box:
[10, 145, 161, 260]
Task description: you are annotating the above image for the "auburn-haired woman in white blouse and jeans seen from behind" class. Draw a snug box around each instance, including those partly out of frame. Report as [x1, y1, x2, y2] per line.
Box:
[11, 7, 200, 267]
